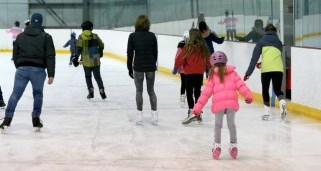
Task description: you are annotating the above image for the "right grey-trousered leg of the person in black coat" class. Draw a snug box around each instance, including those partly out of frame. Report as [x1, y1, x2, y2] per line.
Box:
[146, 72, 157, 111]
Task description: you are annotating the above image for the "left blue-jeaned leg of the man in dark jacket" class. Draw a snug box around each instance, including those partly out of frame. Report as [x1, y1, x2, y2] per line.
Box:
[5, 67, 29, 118]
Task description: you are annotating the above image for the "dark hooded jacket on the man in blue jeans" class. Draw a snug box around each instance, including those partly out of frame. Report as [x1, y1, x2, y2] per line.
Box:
[13, 24, 56, 77]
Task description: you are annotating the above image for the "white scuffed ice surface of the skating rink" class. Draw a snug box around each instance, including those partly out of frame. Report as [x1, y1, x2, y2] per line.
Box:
[0, 53, 321, 171]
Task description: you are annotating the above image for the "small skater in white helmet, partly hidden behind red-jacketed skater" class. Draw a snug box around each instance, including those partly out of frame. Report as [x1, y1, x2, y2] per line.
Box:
[172, 31, 189, 106]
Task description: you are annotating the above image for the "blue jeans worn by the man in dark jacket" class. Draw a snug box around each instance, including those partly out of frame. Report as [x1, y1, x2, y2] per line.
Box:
[5, 66, 47, 118]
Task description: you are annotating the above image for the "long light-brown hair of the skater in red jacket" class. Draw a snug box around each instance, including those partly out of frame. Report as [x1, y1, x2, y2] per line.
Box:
[183, 28, 210, 61]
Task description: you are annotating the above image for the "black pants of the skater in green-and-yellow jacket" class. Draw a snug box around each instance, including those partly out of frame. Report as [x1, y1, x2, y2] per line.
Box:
[84, 66, 104, 90]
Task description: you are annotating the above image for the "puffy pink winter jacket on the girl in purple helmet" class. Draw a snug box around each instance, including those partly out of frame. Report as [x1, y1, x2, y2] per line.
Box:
[193, 65, 253, 114]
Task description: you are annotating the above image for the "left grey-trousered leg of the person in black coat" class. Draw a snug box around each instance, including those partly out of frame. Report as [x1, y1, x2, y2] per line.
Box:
[134, 71, 144, 111]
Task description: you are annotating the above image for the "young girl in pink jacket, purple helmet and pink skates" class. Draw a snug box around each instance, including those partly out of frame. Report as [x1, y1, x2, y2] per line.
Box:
[185, 51, 253, 159]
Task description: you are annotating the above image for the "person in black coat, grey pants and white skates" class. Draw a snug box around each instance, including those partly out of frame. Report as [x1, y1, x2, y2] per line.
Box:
[127, 15, 158, 124]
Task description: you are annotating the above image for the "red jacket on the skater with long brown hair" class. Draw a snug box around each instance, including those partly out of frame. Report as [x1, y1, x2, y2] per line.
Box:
[175, 48, 211, 74]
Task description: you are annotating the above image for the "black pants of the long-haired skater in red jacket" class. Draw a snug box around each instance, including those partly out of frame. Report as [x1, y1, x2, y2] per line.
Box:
[186, 74, 203, 109]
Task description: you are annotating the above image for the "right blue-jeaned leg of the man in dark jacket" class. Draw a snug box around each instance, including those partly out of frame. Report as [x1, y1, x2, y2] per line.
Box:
[29, 67, 47, 118]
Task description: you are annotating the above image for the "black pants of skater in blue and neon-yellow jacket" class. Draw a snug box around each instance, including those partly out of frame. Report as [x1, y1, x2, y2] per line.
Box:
[261, 72, 284, 106]
